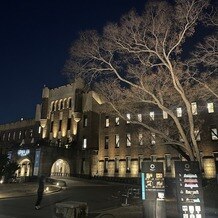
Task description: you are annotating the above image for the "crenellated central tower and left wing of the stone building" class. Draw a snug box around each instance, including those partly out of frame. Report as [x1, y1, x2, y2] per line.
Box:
[0, 80, 99, 180]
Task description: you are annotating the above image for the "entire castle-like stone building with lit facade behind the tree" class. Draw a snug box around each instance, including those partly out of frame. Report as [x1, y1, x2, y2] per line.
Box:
[0, 80, 218, 178]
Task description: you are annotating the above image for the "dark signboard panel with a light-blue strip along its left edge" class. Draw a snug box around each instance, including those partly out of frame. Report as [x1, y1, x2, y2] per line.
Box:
[141, 162, 165, 200]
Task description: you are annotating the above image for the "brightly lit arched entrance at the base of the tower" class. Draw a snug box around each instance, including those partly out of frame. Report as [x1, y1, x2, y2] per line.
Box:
[51, 159, 70, 176]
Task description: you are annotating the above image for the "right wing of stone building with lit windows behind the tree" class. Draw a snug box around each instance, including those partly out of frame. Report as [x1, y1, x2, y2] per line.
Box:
[98, 101, 218, 178]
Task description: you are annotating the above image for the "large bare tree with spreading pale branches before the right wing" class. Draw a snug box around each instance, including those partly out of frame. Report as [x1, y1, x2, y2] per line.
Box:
[66, 0, 218, 162]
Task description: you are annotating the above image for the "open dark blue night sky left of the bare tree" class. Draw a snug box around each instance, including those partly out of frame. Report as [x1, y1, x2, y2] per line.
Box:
[0, 0, 146, 124]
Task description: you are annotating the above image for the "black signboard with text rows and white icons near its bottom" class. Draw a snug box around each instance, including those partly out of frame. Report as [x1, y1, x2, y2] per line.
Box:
[175, 161, 205, 218]
